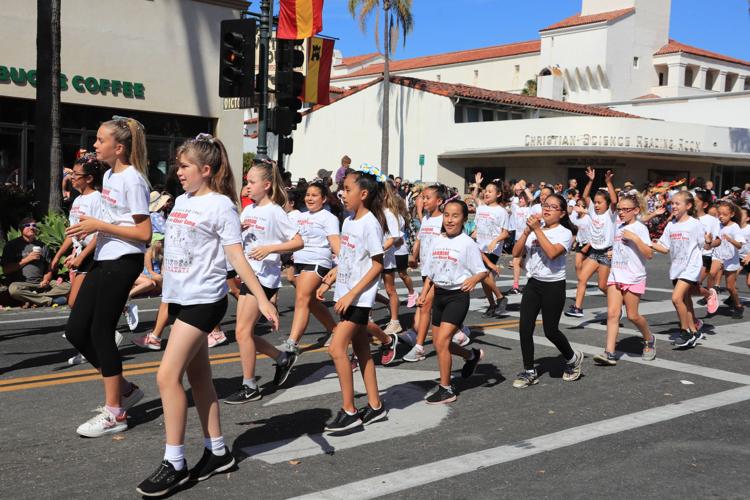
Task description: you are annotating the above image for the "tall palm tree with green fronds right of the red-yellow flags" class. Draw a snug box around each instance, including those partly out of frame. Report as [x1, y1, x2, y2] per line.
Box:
[349, 0, 414, 175]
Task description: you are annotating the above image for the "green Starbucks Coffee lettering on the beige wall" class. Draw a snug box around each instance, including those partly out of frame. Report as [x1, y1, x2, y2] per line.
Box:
[0, 66, 146, 99]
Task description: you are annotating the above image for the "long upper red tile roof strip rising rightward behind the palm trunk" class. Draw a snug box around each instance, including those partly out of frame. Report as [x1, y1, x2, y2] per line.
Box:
[331, 40, 542, 80]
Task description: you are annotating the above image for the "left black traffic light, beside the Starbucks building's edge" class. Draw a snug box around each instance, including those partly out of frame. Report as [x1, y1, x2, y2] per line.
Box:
[219, 19, 255, 99]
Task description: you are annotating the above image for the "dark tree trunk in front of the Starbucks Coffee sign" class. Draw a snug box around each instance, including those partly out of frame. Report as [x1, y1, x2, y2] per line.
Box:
[34, 0, 62, 213]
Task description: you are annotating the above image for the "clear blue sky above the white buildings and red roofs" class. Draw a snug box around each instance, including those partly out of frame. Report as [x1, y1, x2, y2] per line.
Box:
[316, 0, 750, 61]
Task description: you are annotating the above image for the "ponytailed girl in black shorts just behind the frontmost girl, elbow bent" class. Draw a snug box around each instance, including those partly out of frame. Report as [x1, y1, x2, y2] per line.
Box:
[224, 160, 304, 405]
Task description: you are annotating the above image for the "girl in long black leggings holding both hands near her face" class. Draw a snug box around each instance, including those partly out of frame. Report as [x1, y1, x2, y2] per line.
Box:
[513, 194, 583, 389]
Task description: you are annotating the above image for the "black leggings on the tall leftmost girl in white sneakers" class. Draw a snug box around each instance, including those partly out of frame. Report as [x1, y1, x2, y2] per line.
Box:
[65, 253, 143, 377]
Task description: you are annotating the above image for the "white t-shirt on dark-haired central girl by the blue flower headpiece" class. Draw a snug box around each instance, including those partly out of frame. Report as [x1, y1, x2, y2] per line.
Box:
[334, 212, 383, 307]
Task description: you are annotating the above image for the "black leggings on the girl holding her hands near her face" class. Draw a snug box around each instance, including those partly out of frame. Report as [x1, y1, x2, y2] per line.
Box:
[520, 278, 575, 370]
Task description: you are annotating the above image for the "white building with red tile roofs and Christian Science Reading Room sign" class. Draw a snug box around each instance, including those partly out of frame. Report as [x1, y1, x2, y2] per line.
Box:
[280, 0, 750, 191]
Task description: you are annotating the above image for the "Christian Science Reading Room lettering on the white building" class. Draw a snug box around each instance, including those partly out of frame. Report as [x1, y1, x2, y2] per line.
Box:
[524, 134, 701, 153]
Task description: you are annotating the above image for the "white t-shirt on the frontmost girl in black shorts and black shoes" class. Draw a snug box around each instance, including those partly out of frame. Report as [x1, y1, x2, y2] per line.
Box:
[162, 193, 242, 305]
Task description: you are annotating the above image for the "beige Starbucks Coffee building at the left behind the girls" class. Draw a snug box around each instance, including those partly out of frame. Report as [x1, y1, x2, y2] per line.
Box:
[0, 0, 248, 191]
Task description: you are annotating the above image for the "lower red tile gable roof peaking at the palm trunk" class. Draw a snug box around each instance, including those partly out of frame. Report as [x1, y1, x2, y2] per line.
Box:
[302, 76, 640, 118]
